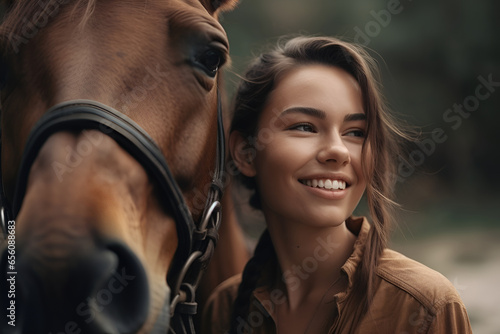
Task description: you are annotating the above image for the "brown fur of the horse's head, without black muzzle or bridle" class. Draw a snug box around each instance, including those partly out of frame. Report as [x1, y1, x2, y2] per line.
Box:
[0, 0, 247, 333]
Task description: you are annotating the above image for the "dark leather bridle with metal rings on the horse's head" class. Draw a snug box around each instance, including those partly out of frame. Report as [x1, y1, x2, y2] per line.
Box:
[0, 96, 225, 333]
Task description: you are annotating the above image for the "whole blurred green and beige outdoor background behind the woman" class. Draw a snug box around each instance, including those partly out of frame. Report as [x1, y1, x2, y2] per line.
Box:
[221, 0, 500, 334]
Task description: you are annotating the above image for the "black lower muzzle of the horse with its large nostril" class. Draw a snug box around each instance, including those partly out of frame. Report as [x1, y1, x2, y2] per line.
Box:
[0, 242, 149, 334]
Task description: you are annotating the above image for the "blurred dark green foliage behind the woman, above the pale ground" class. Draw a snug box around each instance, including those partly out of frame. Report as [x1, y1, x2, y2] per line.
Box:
[221, 0, 500, 232]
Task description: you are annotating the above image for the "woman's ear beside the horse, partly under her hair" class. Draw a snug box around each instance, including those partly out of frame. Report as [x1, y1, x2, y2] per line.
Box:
[229, 131, 257, 177]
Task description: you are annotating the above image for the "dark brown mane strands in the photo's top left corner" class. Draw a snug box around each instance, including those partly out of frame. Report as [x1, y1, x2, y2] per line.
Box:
[0, 0, 97, 53]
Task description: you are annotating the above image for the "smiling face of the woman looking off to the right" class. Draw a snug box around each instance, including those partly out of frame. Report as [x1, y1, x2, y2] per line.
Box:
[245, 65, 367, 226]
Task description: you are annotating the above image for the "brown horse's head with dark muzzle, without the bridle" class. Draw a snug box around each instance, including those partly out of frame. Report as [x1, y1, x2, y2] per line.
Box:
[0, 0, 246, 333]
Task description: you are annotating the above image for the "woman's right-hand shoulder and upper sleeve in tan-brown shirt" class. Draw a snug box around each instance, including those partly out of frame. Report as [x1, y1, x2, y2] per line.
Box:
[360, 249, 472, 334]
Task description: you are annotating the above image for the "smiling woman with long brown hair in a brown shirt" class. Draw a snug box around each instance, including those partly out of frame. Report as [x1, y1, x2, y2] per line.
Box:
[200, 37, 471, 334]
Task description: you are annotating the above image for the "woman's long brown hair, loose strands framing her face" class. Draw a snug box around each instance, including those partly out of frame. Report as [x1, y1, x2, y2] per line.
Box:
[230, 36, 406, 333]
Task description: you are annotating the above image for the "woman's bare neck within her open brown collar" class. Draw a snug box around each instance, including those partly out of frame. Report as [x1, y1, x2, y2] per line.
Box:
[266, 217, 356, 309]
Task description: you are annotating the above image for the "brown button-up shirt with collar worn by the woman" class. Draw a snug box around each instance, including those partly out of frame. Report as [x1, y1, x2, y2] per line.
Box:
[202, 219, 472, 334]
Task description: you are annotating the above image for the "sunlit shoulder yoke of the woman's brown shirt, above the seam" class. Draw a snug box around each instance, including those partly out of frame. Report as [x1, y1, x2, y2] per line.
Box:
[377, 249, 462, 309]
